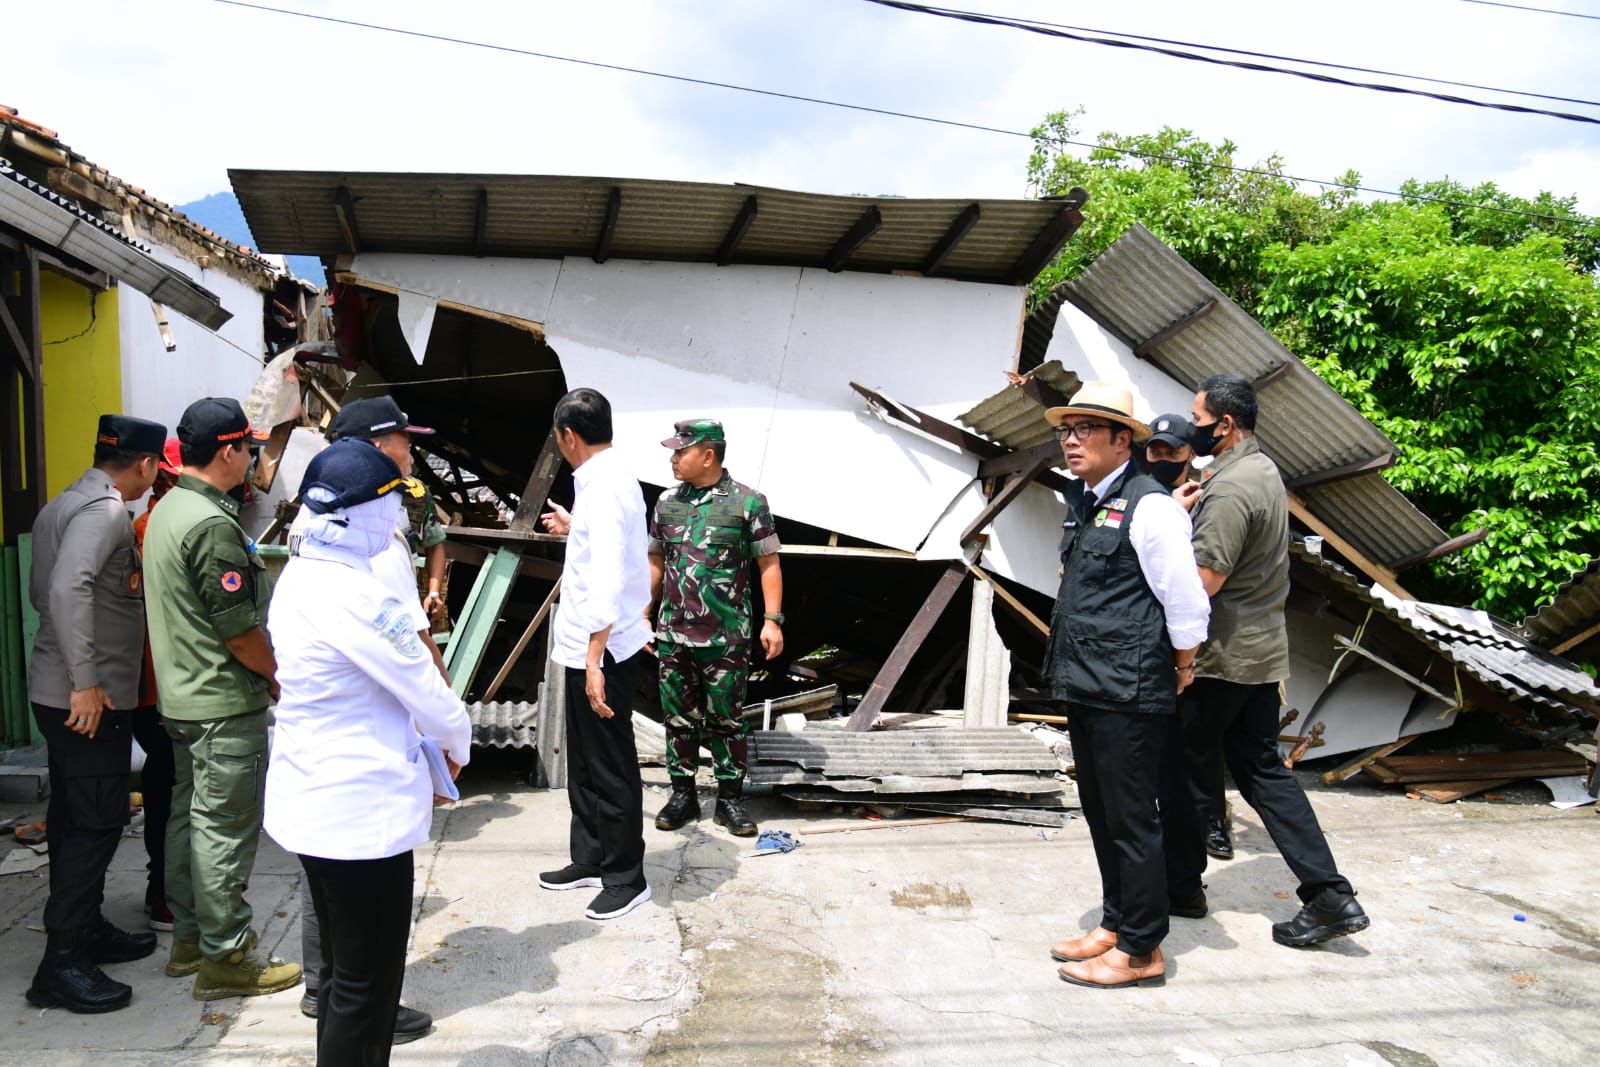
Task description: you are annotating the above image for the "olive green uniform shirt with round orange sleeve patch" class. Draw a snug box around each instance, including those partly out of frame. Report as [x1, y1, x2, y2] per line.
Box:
[144, 474, 272, 721]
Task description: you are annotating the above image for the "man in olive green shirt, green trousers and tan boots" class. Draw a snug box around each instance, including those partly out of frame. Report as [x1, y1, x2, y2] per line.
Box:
[144, 398, 301, 1000]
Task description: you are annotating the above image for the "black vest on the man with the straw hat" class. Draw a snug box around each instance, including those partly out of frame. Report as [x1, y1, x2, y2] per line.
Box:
[1045, 464, 1178, 713]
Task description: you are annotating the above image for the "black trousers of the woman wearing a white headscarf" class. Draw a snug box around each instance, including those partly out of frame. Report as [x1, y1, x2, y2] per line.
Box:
[299, 851, 414, 1067]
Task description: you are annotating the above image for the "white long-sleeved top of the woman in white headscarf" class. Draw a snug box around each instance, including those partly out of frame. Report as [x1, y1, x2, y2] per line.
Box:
[266, 555, 472, 859]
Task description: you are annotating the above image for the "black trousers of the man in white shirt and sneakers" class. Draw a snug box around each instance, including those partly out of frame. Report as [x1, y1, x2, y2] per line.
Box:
[566, 653, 645, 889]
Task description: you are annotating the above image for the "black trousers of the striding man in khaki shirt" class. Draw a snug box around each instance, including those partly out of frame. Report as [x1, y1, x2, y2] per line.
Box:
[1162, 678, 1354, 901]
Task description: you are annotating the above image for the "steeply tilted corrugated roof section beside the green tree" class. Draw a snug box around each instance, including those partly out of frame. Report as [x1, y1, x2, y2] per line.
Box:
[1043, 226, 1446, 566]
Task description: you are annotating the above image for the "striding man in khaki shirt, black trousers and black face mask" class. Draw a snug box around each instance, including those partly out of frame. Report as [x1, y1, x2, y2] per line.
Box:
[1162, 374, 1368, 949]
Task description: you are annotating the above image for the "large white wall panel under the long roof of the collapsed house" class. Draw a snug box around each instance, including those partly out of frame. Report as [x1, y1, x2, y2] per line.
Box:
[352, 254, 1024, 550]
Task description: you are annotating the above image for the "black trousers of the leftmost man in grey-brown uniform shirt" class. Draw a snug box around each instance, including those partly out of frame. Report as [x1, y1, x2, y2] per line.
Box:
[34, 704, 133, 931]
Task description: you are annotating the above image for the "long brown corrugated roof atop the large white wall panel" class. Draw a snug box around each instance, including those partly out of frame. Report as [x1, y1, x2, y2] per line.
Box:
[229, 170, 1086, 283]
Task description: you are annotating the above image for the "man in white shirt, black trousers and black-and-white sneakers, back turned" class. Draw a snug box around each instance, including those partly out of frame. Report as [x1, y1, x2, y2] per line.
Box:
[539, 389, 650, 918]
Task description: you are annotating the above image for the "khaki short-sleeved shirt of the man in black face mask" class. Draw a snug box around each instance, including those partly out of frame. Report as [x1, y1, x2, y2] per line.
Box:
[1194, 437, 1290, 685]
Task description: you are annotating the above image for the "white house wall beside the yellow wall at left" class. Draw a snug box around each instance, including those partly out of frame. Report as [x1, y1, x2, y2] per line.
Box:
[117, 238, 266, 434]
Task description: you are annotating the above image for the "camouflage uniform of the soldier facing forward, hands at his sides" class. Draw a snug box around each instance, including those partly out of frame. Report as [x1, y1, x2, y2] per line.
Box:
[650, 472, 779, 782]
